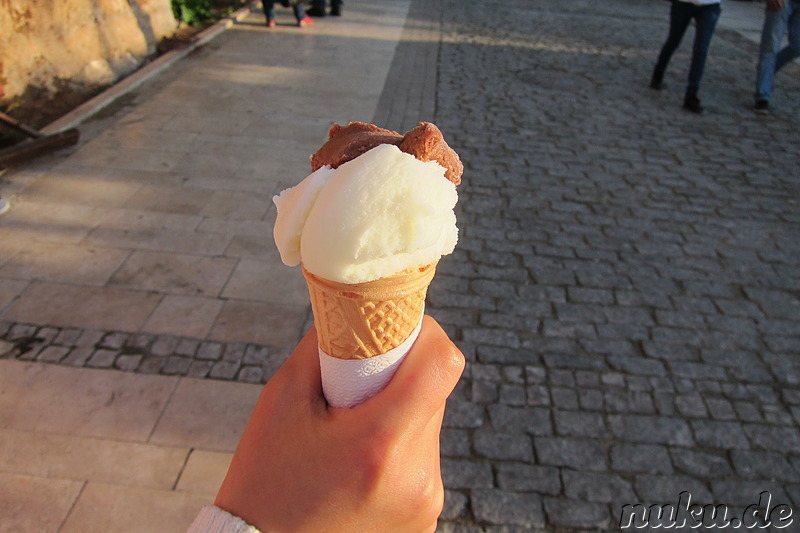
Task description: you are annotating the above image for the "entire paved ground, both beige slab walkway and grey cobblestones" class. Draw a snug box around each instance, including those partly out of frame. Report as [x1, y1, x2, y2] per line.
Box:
[0, 0, 800, 533]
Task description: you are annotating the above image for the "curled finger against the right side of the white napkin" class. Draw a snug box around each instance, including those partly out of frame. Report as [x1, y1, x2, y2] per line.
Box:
[354, 316, 465, 426]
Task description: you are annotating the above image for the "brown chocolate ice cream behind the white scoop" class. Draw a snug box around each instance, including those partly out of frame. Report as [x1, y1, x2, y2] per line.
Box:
[311, 122, 464, 185]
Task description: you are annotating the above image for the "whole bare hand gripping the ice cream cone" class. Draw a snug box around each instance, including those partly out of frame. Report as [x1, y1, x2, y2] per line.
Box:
[215, 316, 464, 533]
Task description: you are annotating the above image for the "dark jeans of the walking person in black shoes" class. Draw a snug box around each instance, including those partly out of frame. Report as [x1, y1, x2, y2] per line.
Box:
[653, 0, 721, 97]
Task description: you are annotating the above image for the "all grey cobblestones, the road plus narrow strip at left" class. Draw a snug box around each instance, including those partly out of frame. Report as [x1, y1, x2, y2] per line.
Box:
[0, 0, 800, 533]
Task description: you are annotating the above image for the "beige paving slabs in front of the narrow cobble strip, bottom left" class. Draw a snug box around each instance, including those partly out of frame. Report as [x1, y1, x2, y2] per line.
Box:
[0, 359, 253, 533]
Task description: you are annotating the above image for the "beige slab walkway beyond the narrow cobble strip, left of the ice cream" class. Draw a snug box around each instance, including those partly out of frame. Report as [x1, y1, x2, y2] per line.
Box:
[0, 0, 412, 346]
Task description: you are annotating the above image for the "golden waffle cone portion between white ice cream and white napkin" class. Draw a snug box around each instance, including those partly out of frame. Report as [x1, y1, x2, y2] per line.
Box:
[303, 263, 436, 359]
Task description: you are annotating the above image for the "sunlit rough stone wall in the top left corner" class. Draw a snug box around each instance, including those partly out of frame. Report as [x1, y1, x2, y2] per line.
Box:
[0, 0, 177, 101]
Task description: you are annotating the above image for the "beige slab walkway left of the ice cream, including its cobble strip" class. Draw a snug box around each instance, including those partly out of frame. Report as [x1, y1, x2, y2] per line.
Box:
[0, 0, 419, 533]
